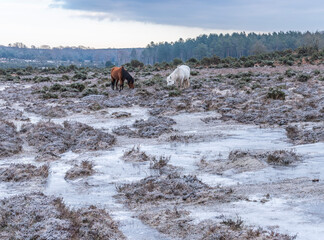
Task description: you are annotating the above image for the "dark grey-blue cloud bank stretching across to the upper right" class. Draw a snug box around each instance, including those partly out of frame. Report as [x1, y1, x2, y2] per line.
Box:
[54, 0, 324, 31]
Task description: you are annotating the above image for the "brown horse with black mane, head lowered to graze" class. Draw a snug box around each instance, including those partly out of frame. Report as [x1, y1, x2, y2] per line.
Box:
[110, 67, 134, 91]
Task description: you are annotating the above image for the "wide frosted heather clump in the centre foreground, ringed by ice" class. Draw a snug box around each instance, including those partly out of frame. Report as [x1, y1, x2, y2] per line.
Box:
[117, 172, 240, 206]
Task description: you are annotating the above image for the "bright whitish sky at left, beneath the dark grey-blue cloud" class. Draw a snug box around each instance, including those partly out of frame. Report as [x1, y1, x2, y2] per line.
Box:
[0, 0, 232, 48]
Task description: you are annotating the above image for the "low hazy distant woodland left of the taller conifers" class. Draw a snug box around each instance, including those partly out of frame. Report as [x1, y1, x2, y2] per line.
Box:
[0, 45, 143, 67]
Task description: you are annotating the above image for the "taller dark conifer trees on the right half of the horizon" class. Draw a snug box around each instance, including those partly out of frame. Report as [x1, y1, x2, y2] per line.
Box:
[139, 31, 324, 64]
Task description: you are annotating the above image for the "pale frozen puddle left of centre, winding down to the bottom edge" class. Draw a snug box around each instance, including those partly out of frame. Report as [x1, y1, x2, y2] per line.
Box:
[45, 148, 173, 240]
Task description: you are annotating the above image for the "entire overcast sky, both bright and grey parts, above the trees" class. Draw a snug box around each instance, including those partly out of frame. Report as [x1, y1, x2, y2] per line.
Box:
[0, 0, 324, 48]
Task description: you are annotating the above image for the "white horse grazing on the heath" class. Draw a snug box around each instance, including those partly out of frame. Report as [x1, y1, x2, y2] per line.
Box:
[167, 65, 190, 88]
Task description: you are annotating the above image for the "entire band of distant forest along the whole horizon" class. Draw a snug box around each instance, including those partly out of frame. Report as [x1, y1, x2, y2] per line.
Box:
[0, 31, 324, 67]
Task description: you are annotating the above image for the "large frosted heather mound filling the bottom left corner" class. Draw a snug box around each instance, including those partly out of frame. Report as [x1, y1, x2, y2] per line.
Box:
[0, 193, 125, 240]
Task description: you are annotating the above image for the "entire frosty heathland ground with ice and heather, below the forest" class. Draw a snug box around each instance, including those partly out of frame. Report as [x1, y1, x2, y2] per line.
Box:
[0, 65, 324, 239]
